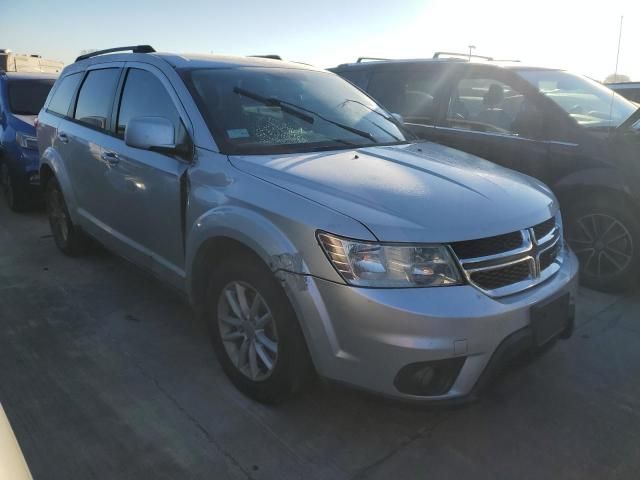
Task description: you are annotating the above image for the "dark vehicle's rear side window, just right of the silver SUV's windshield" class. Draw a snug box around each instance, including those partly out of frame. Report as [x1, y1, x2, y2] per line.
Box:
[369, 68, 440, 125]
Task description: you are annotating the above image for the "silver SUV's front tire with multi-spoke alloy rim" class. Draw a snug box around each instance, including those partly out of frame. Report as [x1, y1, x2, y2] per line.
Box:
[204, 254, 312, 404]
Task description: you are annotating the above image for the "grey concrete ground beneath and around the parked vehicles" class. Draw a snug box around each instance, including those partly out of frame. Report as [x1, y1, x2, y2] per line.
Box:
[0, 203, 640, 480]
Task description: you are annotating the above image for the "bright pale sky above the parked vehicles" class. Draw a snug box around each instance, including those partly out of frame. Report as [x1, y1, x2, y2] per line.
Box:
[0, 0, 640, 81]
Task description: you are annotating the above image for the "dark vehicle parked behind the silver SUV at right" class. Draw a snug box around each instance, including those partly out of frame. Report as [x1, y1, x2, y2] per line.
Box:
[332, 52, 640, 290]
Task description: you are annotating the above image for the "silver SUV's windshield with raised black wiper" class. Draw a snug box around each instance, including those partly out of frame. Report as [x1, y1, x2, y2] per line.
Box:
[183, 68, 409, 154]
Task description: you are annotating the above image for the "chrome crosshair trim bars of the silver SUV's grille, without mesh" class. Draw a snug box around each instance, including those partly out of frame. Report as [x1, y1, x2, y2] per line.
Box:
[452, 214, 565, 297]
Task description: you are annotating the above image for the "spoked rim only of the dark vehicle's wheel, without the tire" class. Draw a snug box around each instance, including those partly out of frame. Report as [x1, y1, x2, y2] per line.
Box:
[568, 213, 634, 277]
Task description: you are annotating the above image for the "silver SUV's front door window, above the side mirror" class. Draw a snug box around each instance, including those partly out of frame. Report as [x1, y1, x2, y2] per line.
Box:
[117, 68, 182, 141]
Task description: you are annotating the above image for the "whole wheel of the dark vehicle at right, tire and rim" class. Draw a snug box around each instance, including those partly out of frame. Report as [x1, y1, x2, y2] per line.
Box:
[565, 197, 640, 292]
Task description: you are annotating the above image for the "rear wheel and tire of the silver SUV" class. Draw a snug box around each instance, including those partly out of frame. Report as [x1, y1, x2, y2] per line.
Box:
[45, 177, 89, 257]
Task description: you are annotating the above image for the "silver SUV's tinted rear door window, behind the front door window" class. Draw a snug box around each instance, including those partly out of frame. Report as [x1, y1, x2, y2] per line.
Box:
[74, 68, 120, 130]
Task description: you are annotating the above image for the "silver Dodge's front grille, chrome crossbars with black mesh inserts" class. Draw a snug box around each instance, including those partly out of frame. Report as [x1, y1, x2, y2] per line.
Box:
[451, 218, 562, 297]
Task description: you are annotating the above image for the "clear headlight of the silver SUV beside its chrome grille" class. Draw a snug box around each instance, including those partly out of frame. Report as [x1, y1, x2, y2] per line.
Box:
[318, 232, 462, 288]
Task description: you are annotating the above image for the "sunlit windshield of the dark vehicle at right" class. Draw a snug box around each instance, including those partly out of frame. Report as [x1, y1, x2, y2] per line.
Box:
[518, 70, 637, 128]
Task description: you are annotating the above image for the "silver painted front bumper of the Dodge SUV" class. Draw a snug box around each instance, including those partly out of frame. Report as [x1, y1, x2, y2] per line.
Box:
[286, 250, 578, 401]
